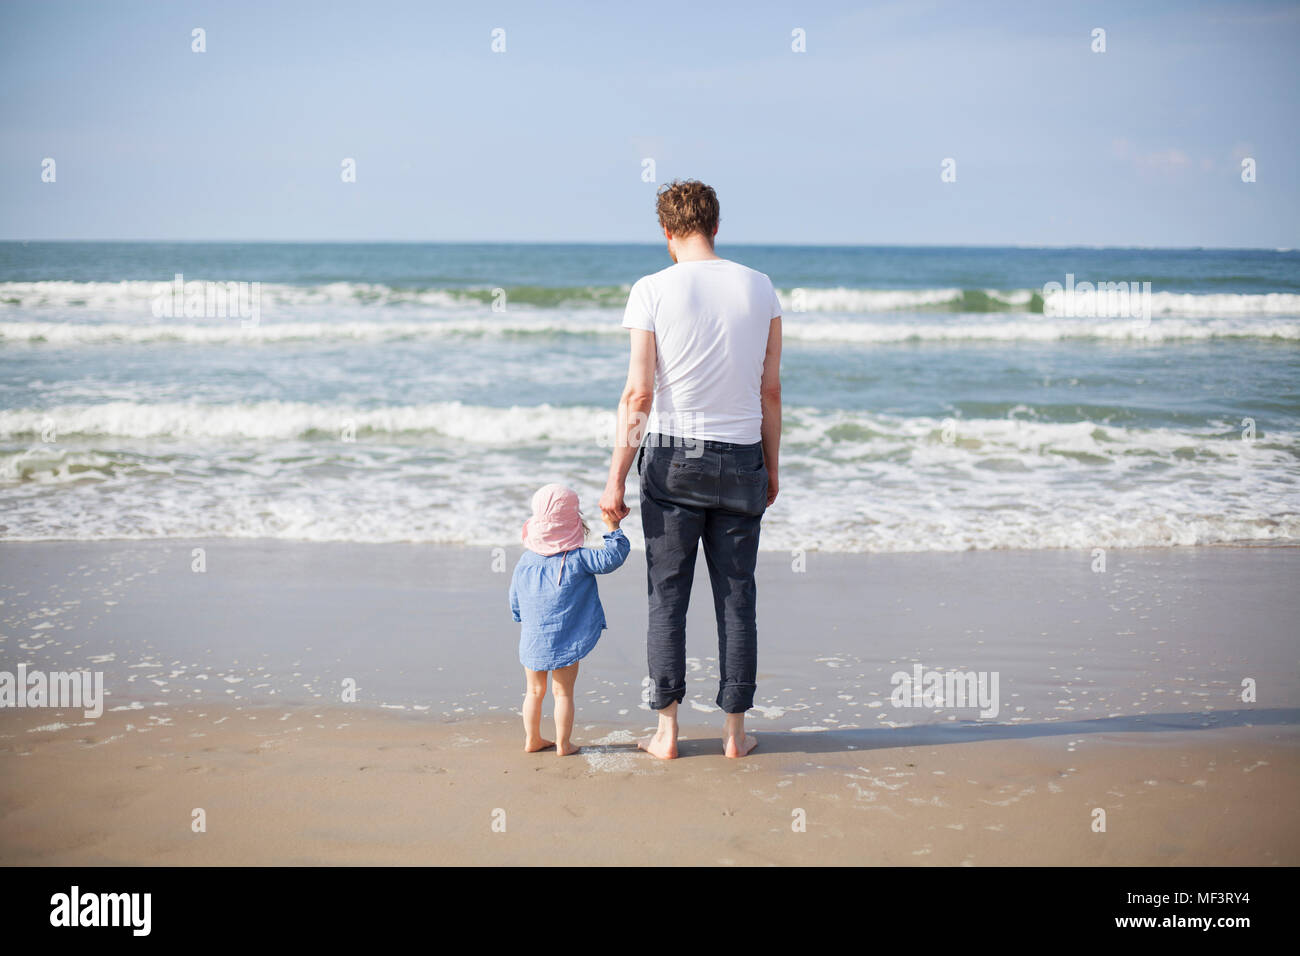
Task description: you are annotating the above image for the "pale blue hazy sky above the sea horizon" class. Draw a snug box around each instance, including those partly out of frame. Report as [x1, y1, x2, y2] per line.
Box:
[0, 0, 1300, 248]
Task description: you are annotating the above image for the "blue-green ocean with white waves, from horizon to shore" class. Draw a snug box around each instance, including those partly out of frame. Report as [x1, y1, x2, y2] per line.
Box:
[0, 242, 1300, 551]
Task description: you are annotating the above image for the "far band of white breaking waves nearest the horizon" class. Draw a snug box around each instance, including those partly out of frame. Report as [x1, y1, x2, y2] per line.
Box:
[0, 281, 1300, 356]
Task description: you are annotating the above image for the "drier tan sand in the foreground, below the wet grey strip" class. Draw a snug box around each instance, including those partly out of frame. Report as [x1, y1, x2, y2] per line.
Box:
[0, 708, 1300, 866]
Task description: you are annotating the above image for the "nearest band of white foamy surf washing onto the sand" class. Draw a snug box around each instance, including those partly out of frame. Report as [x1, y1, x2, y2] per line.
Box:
[0, 402, 1300, 554]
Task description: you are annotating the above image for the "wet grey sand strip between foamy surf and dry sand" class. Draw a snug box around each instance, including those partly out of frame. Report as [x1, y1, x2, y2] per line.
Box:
[0, 540, 1300, 730]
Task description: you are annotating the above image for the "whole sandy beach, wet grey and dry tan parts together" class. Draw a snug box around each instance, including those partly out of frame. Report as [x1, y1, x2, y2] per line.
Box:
[0, 541, 1300, 865]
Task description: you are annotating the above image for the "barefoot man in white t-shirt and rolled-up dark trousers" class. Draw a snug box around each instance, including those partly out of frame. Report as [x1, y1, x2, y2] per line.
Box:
[601, 181, 781, 760]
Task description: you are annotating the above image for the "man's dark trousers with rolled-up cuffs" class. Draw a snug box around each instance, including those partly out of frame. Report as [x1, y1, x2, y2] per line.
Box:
[637, 434, 767, 714]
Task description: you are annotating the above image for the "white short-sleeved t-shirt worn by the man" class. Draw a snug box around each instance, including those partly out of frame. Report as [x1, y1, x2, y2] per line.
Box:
[623, 259, 781, 445]
